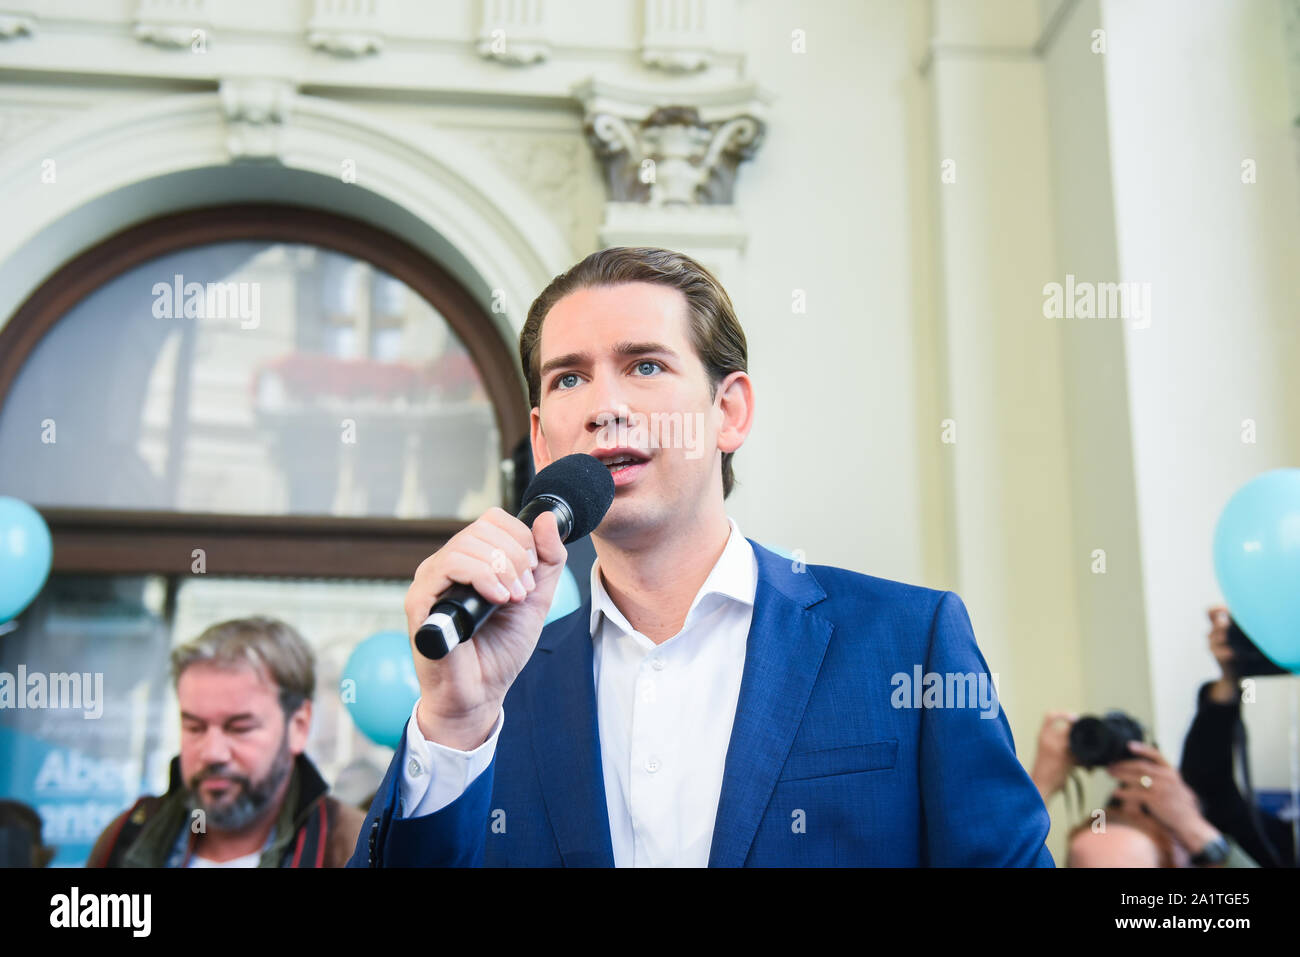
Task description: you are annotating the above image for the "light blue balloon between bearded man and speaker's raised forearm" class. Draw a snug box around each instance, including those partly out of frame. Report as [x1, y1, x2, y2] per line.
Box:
[339, 632, 420, 749]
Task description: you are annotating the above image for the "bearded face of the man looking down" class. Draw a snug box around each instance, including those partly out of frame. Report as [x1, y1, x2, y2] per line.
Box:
[177, 664, 311, 831]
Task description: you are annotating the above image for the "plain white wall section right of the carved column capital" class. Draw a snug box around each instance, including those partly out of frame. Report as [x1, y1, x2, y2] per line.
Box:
[728, 0, 937, 584]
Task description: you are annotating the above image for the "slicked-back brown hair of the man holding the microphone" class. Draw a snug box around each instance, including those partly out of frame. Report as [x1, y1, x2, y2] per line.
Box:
[519, 246, 749, 498]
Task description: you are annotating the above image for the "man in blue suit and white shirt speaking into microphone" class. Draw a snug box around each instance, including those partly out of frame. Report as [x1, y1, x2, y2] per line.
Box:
[350, 247, 1053, 867]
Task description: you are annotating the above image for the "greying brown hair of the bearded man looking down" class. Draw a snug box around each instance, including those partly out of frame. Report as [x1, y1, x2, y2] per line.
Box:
[172, 616, 316, 719]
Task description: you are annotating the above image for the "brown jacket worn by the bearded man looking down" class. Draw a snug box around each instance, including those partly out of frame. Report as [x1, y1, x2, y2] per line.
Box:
[86, 754, 365, 867]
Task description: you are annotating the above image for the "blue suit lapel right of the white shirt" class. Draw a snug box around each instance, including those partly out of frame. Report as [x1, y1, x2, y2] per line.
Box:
[709, 540, 833, 867]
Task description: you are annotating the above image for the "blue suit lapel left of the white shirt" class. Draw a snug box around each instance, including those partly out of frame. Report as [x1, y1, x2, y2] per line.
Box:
[529, 599, 614, 867]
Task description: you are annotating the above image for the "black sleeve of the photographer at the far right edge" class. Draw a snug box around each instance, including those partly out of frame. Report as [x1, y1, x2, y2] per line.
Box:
[1180, 683, 1295, 867]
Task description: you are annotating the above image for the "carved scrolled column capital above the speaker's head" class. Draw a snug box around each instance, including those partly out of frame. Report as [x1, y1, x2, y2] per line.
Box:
[586, 107, 766, 207]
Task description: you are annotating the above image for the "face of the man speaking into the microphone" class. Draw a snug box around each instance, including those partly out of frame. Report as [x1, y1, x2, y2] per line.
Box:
[532, 282, 753, 542]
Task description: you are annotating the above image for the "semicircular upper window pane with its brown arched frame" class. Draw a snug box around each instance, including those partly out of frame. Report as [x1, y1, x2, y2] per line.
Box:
[0, 205, 528, 579]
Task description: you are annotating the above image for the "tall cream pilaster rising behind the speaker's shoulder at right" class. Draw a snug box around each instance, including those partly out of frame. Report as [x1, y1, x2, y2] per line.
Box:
[922, 0, 1083, 859]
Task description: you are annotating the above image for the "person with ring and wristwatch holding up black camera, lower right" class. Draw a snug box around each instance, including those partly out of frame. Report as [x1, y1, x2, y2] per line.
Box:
[1030, 711, 1258, 867]
